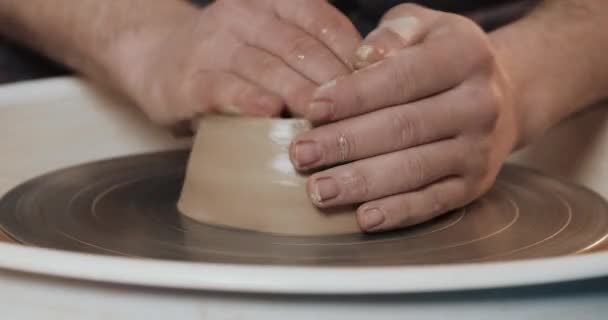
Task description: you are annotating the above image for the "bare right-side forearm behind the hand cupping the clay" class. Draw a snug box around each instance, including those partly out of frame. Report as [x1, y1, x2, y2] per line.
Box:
[490, 0, 608, 145]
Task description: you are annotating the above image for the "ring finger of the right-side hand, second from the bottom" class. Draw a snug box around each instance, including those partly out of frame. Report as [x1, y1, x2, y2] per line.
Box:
[307, 139, 464, 208]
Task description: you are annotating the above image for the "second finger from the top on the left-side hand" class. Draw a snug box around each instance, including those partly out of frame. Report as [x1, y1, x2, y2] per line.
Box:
[238, 6, 350, 84]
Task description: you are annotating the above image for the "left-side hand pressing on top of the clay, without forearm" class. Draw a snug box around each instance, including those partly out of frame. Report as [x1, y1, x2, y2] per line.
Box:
[107, 0, 361, 125]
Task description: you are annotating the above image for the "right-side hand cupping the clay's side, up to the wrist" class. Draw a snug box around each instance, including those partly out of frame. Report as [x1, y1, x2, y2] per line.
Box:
[291, 5, 517, 231]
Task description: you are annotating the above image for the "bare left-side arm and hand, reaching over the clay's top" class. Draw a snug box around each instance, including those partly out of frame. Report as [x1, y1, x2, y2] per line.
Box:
[0, 0, 361, 125]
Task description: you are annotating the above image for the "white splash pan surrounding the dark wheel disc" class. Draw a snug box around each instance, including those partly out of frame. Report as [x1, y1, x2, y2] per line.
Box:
[0, 78, 608, 319]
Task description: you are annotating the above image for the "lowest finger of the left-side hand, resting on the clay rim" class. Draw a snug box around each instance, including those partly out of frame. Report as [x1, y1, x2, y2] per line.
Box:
[191, 71, 283, 119]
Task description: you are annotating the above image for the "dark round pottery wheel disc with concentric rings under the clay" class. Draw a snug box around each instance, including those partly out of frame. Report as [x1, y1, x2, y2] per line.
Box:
[0, 151, 608, 266]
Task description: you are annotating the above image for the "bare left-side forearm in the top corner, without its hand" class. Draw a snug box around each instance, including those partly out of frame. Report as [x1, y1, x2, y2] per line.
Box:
[0, 0, 193, 86]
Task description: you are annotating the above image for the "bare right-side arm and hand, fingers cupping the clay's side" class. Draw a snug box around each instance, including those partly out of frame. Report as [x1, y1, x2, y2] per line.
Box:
[291, 0, 608, 232]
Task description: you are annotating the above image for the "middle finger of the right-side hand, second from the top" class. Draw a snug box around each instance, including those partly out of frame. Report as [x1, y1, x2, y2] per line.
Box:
[290, 91, 466, 171]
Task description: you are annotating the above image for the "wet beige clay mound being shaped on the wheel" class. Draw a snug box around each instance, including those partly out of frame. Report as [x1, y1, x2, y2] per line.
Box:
[178, 116, 360, 236]
